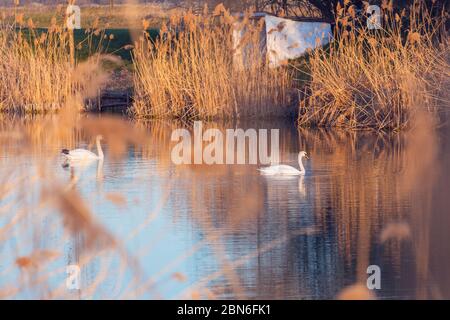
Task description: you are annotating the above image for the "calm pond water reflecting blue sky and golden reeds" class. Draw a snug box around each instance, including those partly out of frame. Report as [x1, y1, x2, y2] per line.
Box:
[0, 118, 450, 299]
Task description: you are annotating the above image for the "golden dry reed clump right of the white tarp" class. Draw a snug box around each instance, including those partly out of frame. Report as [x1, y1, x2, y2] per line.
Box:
[298, 0, 450, 130]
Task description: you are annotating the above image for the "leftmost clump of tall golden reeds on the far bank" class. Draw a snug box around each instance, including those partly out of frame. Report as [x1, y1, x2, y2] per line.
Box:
[0, 16, 71, 112]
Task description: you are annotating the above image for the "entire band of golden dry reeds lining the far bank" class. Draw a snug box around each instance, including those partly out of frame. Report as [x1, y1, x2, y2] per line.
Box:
[0, 0, 450, 131]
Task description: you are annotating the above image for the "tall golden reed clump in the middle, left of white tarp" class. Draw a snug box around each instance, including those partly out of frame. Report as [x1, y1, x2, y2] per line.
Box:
[132, 5, 291, 118]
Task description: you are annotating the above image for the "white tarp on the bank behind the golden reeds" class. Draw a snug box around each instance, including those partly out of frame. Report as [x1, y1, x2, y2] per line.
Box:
[233, 14, 332, 67]
